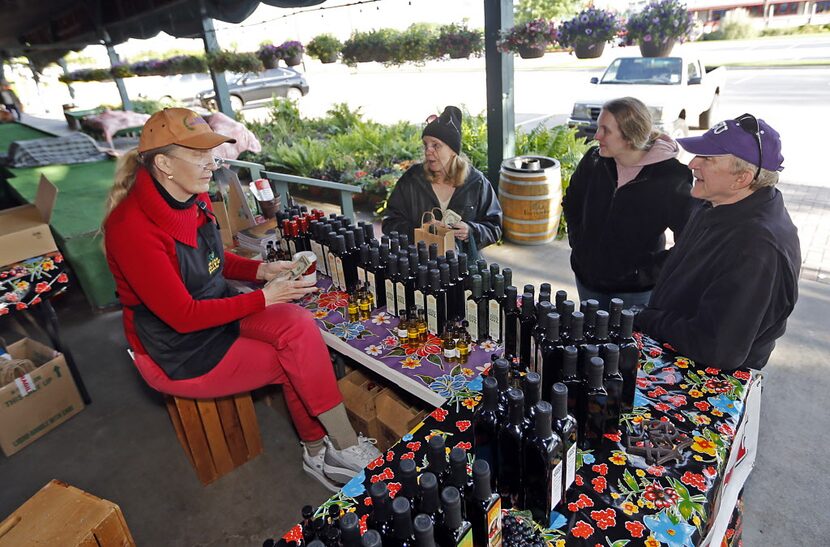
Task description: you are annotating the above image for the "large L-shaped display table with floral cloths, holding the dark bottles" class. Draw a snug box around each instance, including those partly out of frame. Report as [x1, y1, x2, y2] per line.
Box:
[272, 284, 762, 547]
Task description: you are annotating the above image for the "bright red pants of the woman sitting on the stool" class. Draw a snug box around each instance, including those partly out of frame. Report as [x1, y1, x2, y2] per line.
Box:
[135, 304, 343, 441]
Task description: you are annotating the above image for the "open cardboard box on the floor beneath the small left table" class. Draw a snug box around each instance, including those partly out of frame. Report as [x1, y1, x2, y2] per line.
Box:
[0, 338, 84, 456]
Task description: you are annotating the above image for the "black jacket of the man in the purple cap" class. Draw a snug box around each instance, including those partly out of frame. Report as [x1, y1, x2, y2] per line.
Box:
[636, 188, 801, 370]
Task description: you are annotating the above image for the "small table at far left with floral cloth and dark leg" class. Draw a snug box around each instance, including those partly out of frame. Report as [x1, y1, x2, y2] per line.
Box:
[0, 251, 92, 404]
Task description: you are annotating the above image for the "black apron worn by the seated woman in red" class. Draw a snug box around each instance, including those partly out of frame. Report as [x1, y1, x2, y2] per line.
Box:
[132, 201, 239, 380]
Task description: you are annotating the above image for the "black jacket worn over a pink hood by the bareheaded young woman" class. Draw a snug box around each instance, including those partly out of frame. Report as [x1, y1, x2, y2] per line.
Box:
[562, 147, 696, 292]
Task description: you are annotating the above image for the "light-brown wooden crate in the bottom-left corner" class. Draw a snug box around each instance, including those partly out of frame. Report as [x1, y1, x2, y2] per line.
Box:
[0, 480, 135, 547]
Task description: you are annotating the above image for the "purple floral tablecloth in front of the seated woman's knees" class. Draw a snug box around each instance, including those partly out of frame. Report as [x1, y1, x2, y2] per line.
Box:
[300, 276, 503, 400]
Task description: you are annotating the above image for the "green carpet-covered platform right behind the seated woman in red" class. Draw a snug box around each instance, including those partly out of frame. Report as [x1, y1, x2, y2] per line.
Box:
[8, 160, 117, 308]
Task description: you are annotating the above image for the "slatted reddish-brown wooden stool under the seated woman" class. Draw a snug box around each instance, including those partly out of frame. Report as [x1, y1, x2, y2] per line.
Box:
[167, 393, 262, 484]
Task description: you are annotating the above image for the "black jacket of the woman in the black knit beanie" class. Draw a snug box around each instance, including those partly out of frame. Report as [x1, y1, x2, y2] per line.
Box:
[383, 163, 502, 248]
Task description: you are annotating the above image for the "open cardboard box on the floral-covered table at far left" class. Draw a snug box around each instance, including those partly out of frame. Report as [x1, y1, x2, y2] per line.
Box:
[0, 175, 58, 266]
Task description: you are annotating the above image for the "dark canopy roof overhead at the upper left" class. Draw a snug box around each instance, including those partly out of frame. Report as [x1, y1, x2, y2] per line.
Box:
[0, 0, 325, 66]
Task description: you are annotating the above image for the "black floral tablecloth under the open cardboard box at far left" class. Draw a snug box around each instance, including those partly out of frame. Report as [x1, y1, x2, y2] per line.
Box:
[0, 251, 69, 316]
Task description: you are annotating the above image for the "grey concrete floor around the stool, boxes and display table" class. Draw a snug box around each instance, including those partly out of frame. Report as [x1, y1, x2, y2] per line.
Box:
[0, 233, 830, 546]
